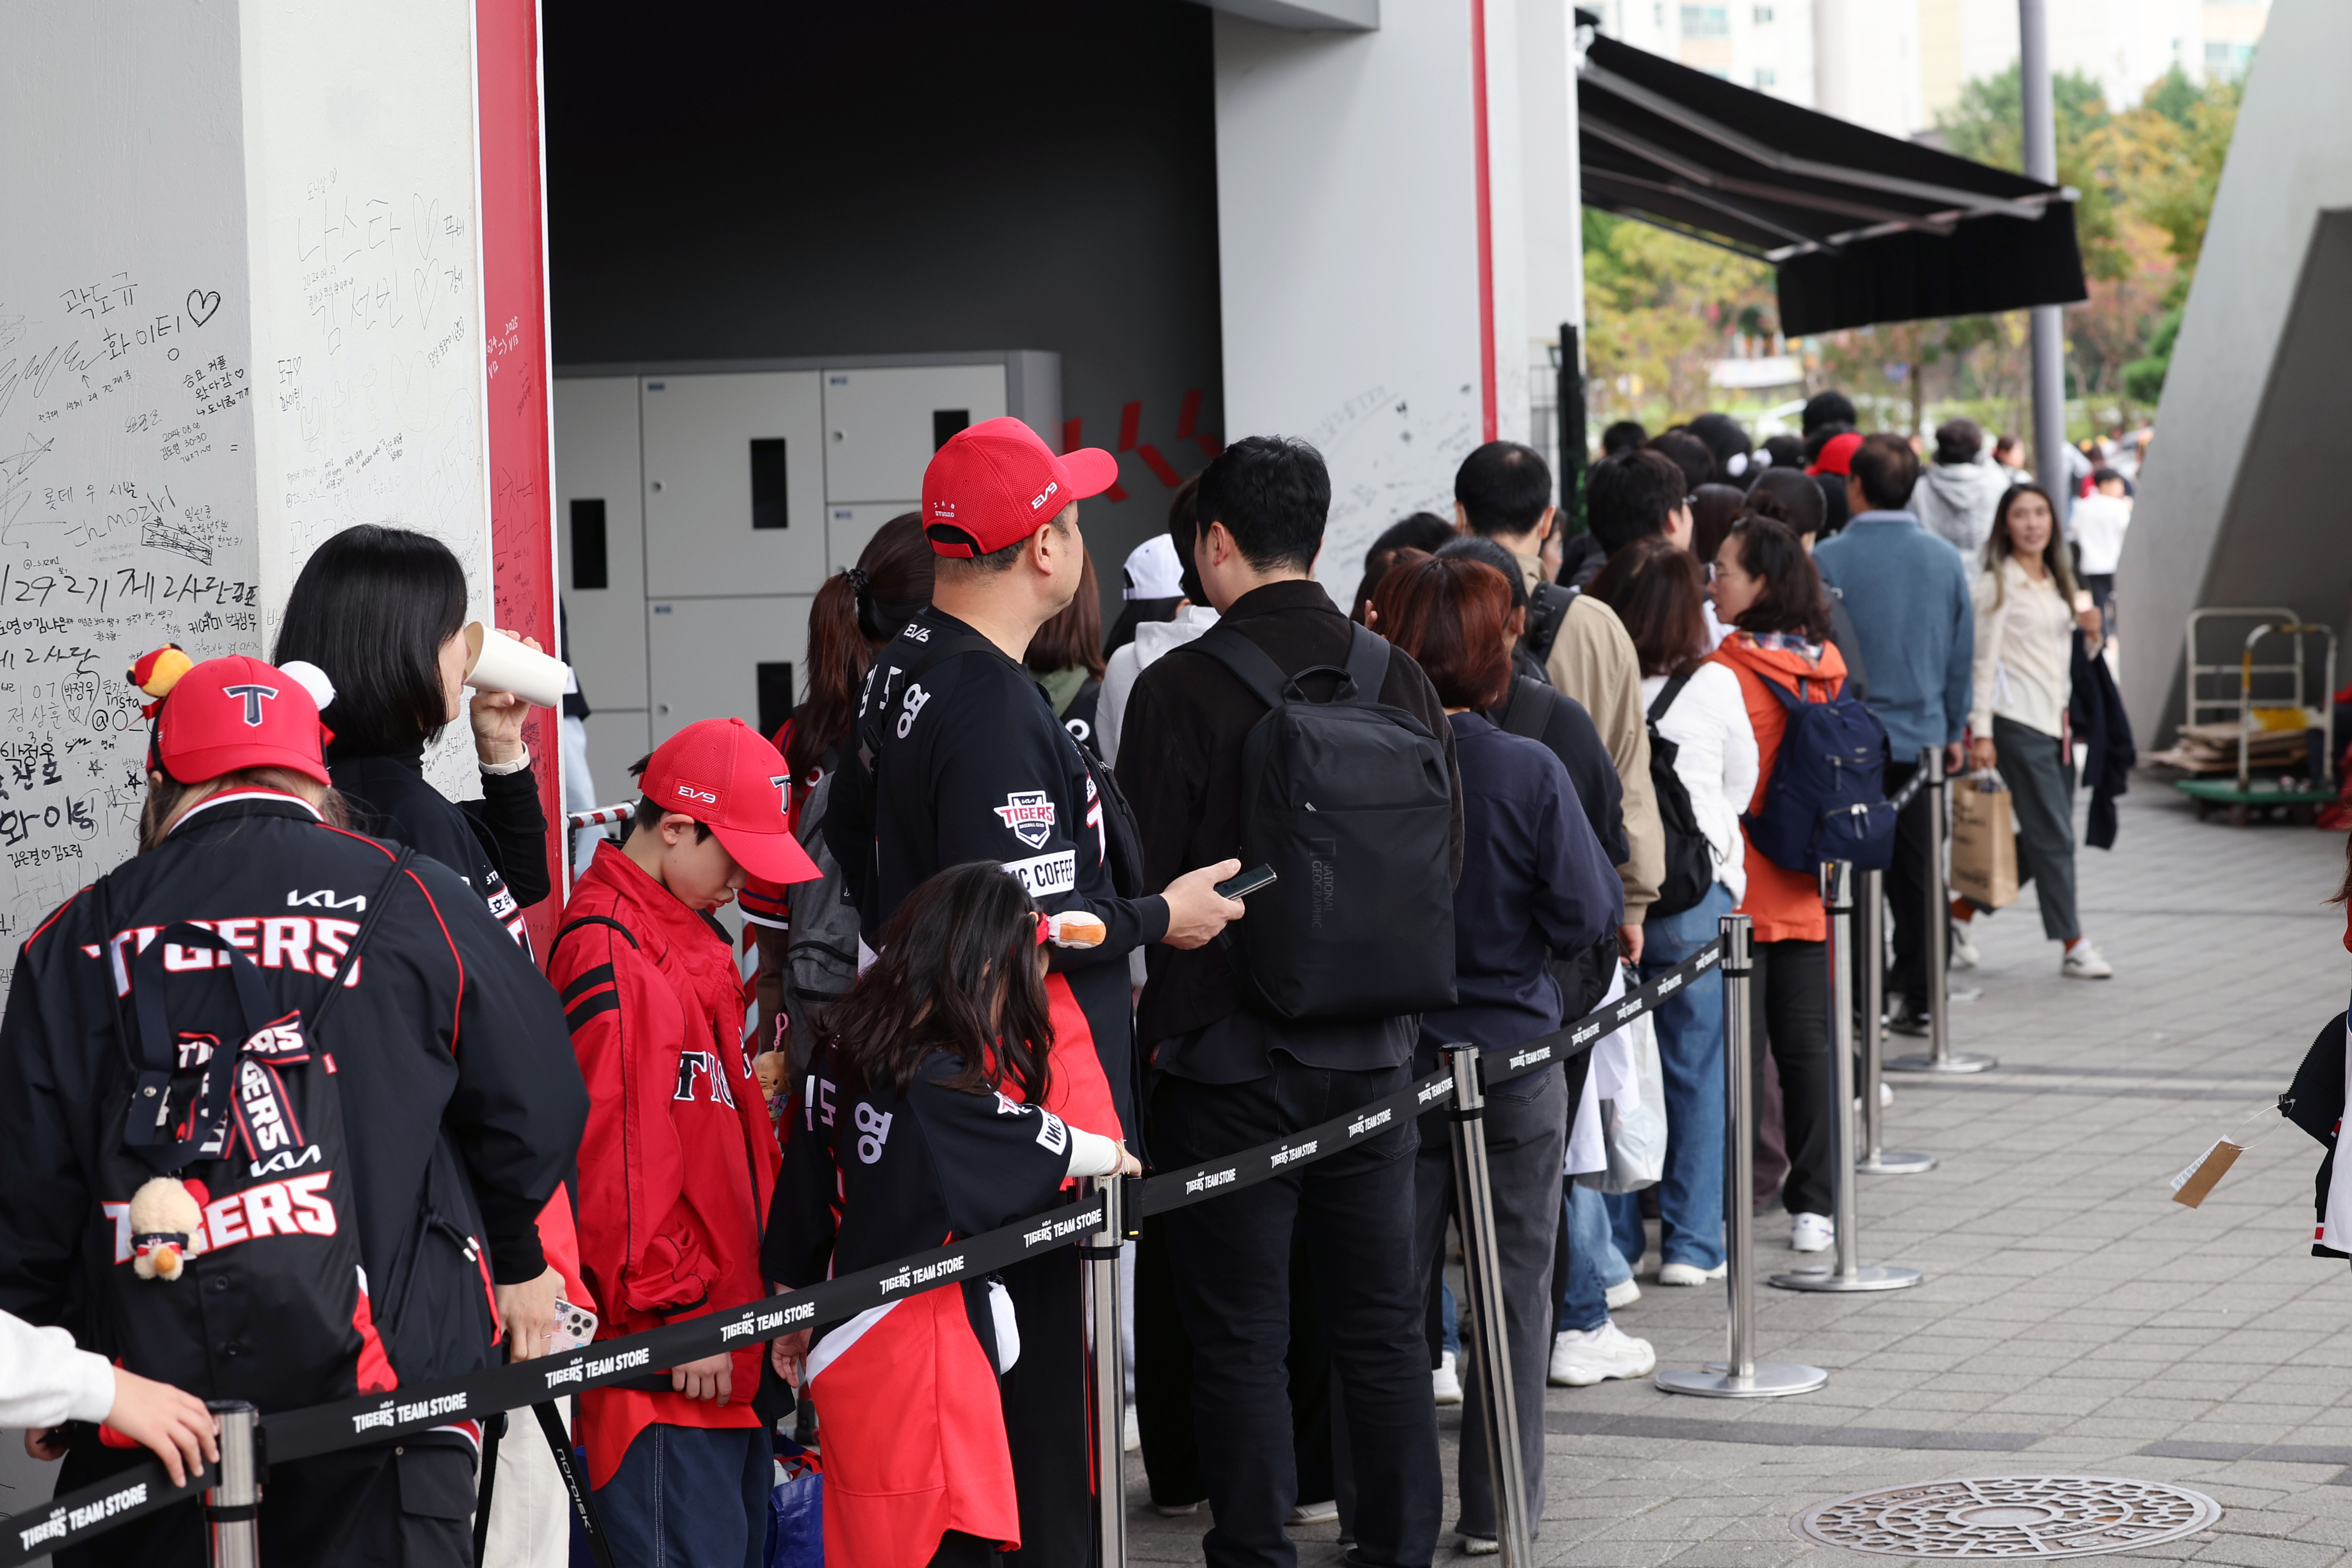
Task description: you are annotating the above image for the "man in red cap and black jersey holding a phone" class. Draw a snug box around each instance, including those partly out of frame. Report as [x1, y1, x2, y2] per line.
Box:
[826, 419, 1242, 1568]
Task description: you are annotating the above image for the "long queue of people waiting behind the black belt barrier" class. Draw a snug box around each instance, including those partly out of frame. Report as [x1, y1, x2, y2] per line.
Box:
[0, 404, 2112, 1568]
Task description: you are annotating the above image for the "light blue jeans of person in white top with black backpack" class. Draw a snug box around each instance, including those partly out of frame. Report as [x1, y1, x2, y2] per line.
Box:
[1609, 881, 1731, 1269]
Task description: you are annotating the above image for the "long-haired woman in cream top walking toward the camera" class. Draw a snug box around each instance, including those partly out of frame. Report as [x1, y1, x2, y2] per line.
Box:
[1952, 484, 2114, 980]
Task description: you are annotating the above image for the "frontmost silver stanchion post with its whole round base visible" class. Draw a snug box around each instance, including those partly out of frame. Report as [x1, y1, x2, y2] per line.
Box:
[1658, 914, 1830, 1399]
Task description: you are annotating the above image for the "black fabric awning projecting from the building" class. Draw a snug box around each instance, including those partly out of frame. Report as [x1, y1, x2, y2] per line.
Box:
[1576, 38, 2086, 336]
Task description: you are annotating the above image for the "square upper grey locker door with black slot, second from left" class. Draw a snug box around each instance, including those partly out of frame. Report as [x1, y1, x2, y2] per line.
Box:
[642, 372, 826, 597]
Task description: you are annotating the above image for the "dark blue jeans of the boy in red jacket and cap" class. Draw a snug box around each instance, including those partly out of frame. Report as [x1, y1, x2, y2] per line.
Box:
[593, 1422, 776, 1568]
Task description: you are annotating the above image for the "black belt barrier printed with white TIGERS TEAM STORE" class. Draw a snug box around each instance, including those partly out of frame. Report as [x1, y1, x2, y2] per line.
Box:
[0, 940, 1722, 1568]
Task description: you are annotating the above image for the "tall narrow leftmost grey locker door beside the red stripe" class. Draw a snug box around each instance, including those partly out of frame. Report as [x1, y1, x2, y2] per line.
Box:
[553, 376, 644, 710]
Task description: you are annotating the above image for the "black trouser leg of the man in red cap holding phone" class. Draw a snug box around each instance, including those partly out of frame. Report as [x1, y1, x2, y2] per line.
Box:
[1002, 1246, 1094, 1568]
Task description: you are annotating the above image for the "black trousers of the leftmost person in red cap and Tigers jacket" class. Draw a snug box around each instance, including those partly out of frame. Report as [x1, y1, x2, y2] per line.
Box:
[56, 1434, 473, 1568]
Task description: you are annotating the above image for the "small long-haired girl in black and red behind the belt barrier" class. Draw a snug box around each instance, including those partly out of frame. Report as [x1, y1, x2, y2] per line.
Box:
[762, 862, 1141, 1568]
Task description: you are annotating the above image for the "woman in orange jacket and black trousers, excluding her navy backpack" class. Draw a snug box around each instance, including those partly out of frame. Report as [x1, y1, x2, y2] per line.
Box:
[1712, 517, 1846, 1253]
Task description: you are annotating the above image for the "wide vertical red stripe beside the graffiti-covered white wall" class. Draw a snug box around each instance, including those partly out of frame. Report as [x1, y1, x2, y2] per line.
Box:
[475, 0, 569, 954]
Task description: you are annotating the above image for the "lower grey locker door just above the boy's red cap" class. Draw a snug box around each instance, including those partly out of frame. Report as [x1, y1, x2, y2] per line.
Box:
[649, 593, 814, 762]
